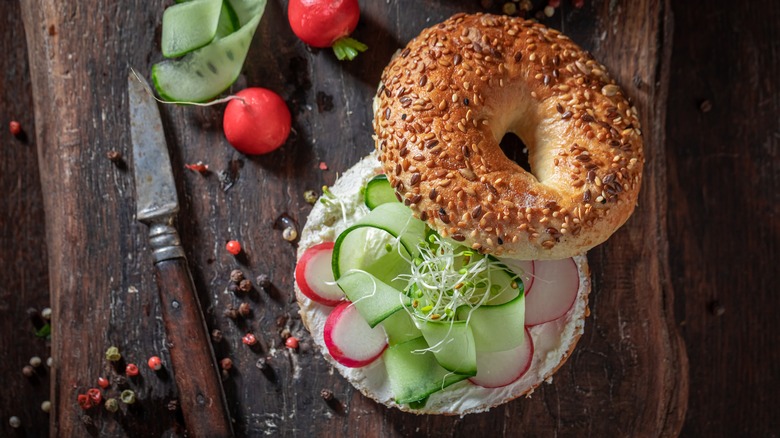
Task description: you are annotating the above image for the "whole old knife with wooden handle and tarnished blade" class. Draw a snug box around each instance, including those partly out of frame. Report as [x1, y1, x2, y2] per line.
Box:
[128, 70, 233, 437]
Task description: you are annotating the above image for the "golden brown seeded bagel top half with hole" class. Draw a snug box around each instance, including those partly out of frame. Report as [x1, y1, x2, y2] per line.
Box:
[374, 14, 644, 259]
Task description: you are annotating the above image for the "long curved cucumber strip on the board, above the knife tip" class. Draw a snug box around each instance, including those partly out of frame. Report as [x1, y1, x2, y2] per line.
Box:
[152, 0, 266, 102]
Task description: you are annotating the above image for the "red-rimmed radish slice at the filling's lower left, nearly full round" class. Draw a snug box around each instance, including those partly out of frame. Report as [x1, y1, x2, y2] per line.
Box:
[323, 301, 387, 368]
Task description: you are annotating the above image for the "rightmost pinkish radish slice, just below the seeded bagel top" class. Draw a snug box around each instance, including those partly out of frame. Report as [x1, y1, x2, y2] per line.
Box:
[525, 258, 580, 326]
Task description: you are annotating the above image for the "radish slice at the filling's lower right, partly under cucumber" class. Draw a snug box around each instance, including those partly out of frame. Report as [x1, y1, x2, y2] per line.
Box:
[469, 328, 534, 388]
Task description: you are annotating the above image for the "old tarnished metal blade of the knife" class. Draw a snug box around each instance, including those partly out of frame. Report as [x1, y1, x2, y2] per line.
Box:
[127, 71, 179, 222]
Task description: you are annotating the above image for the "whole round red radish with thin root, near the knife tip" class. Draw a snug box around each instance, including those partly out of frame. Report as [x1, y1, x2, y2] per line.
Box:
[222, 87, 291, 155]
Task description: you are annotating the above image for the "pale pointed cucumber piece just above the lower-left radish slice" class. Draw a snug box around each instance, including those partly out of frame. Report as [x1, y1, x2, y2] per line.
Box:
[336, 271, 412, 328]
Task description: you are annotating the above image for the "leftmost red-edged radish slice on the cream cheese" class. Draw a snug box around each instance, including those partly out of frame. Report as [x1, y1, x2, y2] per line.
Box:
[295, 242, 344, 306]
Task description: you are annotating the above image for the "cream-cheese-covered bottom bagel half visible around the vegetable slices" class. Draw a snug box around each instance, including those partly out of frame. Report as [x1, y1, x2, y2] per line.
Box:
[295, 154, 591, 415]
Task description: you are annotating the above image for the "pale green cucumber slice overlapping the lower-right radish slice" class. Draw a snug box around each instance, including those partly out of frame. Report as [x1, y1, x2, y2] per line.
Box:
[455, 289, 525, 352]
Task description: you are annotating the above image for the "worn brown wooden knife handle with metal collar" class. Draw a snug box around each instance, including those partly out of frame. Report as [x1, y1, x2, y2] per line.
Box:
[150, 227, 233, 438]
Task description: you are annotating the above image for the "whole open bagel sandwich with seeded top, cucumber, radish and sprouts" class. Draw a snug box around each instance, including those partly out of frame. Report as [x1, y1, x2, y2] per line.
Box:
[295, 14, 643, 415]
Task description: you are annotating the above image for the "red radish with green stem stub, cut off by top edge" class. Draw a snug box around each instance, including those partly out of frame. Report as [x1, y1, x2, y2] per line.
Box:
[287, 0, 368, 60]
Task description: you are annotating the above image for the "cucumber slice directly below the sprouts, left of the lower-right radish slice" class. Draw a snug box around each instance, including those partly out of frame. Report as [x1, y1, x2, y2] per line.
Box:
[420, 321, 477, 376]
